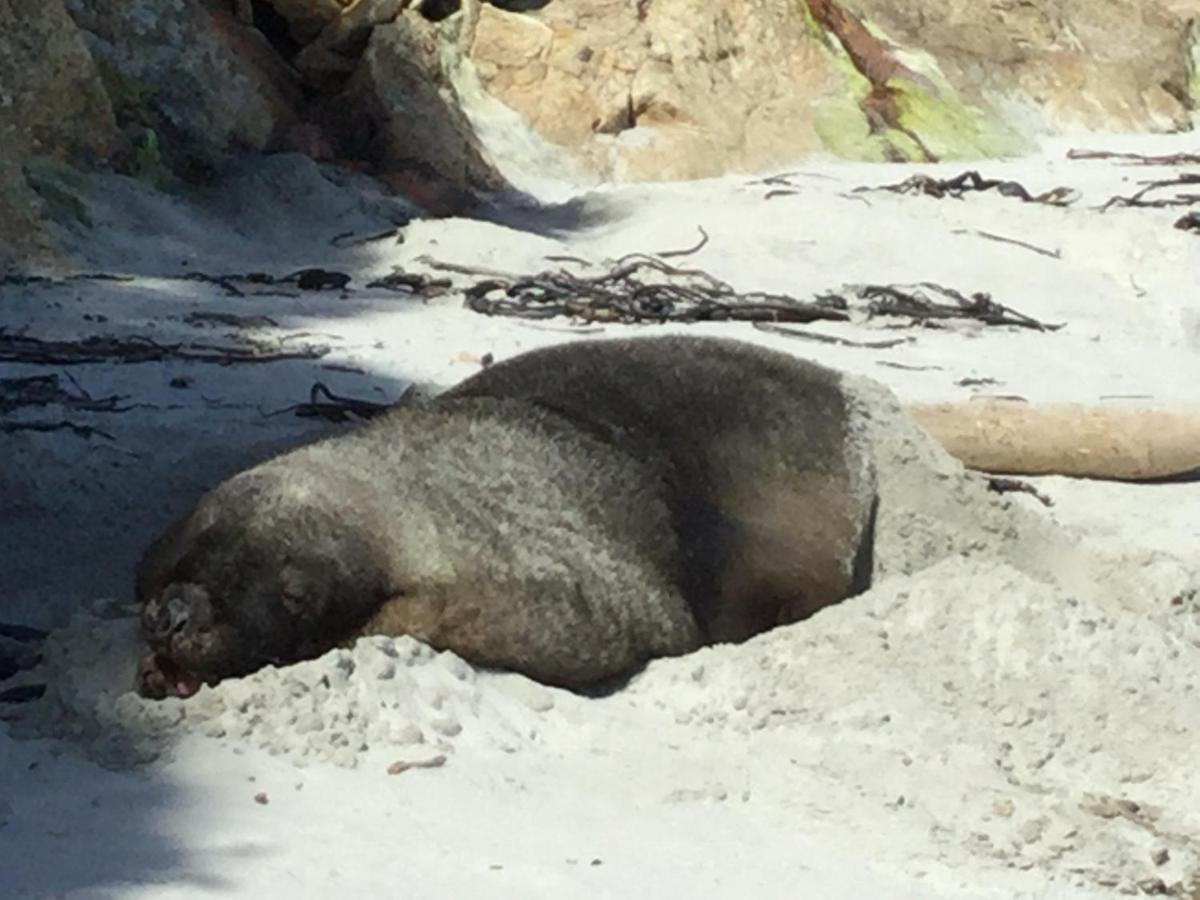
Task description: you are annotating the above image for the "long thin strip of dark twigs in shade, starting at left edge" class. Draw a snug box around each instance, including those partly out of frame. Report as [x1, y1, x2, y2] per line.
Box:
[0, 329, 329, 366]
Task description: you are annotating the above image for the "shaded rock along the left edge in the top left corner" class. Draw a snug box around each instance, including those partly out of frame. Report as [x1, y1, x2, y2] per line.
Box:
[0, 0, 122, 271]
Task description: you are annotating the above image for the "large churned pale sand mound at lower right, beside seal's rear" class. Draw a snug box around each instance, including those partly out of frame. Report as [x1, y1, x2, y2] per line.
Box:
[628, 558, 1200, 889]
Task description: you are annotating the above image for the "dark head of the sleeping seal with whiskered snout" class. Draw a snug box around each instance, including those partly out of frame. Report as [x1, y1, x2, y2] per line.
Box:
[137, 469, 397, 697]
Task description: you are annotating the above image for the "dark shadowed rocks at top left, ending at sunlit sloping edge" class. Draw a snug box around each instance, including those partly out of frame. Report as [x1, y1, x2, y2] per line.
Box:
[0, 0, 505, 271]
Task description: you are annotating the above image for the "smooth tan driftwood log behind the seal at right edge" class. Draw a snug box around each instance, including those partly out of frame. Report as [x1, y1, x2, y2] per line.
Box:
[908, 400, 1200, 481]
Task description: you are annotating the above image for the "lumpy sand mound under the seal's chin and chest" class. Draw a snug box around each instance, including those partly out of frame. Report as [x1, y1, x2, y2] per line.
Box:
[14, 610, 554, 767]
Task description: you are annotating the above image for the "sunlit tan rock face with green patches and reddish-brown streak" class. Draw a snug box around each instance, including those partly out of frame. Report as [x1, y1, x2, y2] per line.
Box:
[453, 0, 1200, 179]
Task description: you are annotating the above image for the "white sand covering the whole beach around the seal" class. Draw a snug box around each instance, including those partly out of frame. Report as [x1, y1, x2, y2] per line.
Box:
[0, 132, 1200, 898]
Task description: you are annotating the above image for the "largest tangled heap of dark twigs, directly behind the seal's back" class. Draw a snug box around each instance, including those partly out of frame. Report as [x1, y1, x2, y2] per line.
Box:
[446, 247, 848, 323]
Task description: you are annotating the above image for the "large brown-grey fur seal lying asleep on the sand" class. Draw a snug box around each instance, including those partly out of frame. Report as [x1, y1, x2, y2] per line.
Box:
[137, 337, 876, 696]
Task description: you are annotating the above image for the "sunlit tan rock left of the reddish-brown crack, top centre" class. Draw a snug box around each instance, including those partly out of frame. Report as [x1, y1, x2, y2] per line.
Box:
[466, 0, 835, 180]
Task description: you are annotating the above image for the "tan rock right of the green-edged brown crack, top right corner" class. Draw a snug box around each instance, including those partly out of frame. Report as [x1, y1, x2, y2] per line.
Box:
[841, 0, 1200, 131]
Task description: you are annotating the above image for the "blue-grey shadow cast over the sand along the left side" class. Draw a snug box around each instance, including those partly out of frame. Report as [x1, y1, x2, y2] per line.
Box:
[0, 156, 613, 896]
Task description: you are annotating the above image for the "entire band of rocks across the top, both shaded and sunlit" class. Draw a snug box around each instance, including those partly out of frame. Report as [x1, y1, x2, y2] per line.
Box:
[0, 0, 1200, 274]
